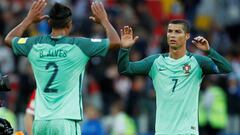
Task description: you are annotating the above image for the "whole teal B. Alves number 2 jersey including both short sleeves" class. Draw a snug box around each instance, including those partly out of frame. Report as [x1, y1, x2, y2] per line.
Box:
[12, 35, 109, 120]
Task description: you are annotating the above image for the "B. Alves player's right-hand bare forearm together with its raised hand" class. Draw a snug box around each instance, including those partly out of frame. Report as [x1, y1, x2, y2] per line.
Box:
[89, 1, 120, 49]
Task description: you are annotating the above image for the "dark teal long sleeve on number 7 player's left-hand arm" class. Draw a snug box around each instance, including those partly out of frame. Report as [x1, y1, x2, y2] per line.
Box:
[118, 49, 159, 75]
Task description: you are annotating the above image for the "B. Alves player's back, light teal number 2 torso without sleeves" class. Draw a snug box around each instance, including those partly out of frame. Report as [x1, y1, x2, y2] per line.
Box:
[28, 36, 89, 119]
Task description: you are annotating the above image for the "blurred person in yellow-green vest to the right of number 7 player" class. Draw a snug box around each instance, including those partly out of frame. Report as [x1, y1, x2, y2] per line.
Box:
[199, 79, 228, 135]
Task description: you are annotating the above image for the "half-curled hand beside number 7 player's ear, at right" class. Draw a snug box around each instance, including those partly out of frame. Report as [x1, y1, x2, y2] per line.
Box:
[192, 36, 210, 51]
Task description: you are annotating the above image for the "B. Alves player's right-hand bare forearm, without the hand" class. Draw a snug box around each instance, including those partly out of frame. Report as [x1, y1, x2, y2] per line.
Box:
[102, 20, 120, 49]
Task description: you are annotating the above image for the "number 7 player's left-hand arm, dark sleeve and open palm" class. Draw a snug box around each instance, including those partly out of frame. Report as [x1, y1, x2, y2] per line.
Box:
[118, 26, 158, 75]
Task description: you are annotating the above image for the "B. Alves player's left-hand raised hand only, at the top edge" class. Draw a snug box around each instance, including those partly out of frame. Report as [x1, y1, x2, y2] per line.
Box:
[26, 0, 48, 23]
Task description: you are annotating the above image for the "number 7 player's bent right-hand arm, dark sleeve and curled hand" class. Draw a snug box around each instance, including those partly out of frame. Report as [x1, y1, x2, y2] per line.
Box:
[192, 37, 232, 74]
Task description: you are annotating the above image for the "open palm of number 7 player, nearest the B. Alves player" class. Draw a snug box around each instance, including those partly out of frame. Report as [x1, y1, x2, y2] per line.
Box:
[121, 26, 138, 48]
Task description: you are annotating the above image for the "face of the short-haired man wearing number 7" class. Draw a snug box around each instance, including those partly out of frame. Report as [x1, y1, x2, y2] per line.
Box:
[167, 24, 190, 50]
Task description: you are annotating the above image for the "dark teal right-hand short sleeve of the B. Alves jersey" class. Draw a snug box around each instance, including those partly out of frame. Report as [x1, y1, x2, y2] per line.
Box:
[77, 38, 109, 57]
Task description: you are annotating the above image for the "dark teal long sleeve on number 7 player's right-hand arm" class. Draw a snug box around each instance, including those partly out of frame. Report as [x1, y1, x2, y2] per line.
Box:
[194, 49, 232, 74]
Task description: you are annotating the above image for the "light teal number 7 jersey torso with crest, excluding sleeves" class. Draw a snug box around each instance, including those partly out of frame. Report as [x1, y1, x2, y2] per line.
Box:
[149, 55, 202, 135]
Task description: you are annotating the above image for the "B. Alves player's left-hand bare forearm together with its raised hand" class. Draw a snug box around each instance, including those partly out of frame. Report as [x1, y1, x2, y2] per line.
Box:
[4, 0, 47, 47]
